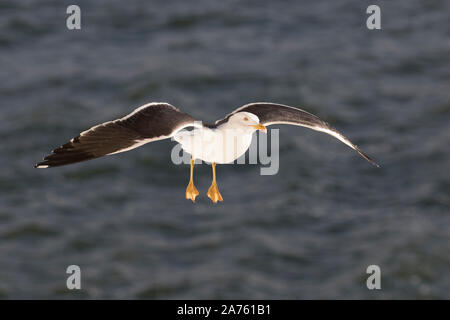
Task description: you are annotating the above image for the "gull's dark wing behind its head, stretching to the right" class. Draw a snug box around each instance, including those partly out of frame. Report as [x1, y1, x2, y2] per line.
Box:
[216, 102, 379, 167]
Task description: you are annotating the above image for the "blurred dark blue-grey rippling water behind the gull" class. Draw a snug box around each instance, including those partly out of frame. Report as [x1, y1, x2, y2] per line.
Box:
[0, 0, 450, 299]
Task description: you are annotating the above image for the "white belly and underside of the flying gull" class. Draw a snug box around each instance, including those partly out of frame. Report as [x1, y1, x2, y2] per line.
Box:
[174, 128, 252, 163]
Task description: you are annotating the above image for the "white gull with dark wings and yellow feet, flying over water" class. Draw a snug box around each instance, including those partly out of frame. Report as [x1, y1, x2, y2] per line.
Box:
[35, 102, 379, 203]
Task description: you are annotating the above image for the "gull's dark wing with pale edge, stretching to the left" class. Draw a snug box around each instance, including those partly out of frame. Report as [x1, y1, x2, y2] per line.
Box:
[35, 102, 195, 168]
